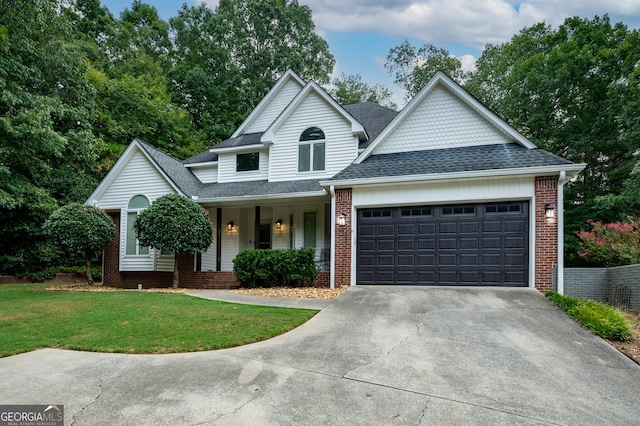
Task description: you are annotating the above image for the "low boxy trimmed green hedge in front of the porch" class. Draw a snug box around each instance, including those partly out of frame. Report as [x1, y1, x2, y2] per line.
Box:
[233, 247, 318, 287]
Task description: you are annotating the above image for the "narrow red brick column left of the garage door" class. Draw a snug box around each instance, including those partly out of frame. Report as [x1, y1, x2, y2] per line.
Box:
[333, 188, 353, 287]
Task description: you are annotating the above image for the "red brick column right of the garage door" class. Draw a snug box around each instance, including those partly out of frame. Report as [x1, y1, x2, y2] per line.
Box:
[534, 176, 558, 292]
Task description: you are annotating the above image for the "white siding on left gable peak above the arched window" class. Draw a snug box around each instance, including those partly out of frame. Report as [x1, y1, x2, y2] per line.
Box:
[98, 151, 175, 211]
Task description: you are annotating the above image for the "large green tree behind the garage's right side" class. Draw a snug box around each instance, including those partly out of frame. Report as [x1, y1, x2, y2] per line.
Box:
[465, 16, 640, 262]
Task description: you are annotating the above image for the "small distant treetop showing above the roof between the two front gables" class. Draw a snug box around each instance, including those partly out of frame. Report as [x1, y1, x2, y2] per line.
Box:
[329, 73, 398, 109]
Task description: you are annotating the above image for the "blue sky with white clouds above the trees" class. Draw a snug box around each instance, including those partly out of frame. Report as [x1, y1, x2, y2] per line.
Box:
[101, 0, 640, 105]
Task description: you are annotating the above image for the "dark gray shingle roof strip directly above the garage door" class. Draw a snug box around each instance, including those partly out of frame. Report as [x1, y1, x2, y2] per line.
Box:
[330, 143, 572, 180]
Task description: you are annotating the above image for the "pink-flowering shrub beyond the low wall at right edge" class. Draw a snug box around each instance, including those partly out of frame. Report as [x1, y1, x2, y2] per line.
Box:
[578, 216, 640, 266]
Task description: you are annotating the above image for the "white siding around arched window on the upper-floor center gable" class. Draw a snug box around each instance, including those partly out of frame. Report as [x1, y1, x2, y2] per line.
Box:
[269, 93, 358, 182]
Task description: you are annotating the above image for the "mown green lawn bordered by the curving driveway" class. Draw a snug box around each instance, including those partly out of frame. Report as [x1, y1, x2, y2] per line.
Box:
[0, 284, 317, 357]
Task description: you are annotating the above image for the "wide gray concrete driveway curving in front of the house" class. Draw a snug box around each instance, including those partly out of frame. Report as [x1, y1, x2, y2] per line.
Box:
[0, 287, 640, 425]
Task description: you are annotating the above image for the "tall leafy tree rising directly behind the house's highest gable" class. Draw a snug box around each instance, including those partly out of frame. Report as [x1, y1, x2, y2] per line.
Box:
[170, 0, 335, 141]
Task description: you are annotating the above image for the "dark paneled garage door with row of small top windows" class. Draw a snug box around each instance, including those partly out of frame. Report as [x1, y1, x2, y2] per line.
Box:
[356, 201, 529, 287]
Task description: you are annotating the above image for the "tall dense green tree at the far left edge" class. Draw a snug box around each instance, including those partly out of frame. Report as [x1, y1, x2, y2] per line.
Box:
[0, 0, 100, 272]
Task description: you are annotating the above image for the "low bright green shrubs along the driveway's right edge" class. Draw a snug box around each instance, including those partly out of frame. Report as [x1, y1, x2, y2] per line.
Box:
[545, 291, 633, 340]
